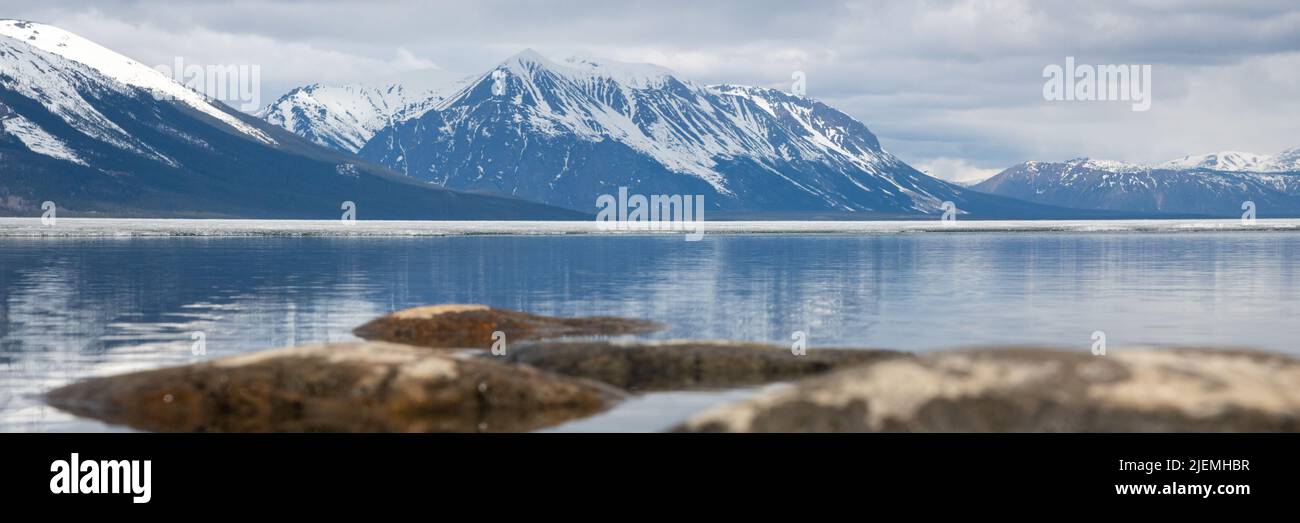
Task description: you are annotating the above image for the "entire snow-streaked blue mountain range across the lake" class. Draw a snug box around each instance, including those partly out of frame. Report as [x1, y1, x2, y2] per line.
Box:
[0, 21, 1300, 220]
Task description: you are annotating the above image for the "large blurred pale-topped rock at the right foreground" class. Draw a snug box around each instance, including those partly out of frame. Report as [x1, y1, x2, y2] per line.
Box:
[679, 349, 1300, 432]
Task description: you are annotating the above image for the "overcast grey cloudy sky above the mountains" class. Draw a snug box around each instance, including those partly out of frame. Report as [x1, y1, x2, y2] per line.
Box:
[0, 0, 1300, 180]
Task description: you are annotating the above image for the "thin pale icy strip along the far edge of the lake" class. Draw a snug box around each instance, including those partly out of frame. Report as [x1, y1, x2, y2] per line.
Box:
[0, 217, 1300, 238]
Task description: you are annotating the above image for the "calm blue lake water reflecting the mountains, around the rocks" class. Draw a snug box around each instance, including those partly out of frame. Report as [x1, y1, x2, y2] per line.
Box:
[0, 232, 1300, 431]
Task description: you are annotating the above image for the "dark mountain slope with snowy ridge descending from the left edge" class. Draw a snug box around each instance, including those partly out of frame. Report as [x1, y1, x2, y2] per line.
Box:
[0, 20, 582, 219]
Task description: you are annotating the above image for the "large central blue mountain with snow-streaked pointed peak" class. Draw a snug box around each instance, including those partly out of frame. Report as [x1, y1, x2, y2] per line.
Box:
[266, 49, 1066, 216]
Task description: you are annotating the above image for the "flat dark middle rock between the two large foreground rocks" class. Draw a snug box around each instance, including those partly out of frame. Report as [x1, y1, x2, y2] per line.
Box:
[506, 341, 904, 390]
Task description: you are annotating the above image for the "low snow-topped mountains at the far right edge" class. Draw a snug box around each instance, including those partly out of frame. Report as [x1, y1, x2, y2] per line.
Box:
[974, 150, 1300, 217]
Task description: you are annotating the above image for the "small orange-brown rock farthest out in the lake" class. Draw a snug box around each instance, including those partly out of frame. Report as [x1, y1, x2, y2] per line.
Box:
[352, 304, 663, 349]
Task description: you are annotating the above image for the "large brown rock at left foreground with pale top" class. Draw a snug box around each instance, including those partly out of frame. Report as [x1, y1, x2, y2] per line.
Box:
[47, 342, 621, 432]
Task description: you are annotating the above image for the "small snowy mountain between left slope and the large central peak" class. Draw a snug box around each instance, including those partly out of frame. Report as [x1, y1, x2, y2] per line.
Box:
[257, 72, 468, 152]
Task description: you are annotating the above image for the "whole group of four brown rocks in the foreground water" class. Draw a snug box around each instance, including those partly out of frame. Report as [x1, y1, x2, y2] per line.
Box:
[46, 304, 1300, 432]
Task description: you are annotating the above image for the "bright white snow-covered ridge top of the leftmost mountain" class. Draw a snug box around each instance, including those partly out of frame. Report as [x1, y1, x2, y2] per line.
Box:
[0, 20, 276, 143]
